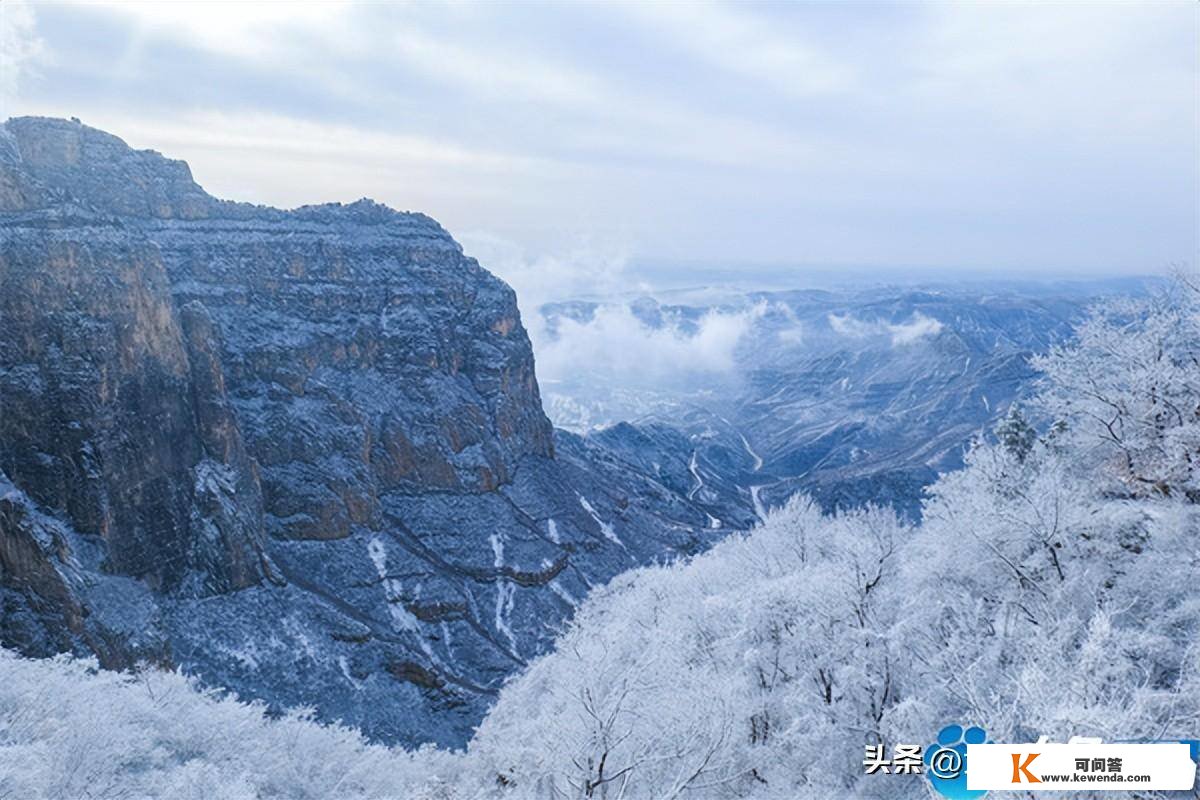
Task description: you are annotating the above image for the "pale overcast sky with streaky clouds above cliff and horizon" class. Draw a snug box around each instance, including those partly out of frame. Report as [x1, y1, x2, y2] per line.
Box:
[0, 0, 1200, 282]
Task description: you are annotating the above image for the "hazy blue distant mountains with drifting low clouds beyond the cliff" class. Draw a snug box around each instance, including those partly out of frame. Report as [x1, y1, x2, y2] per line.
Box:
[540, 279, 1151, 516]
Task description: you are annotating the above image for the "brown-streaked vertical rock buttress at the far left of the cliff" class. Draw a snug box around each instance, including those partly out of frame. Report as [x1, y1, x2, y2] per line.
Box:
[0, 137, 262, 594]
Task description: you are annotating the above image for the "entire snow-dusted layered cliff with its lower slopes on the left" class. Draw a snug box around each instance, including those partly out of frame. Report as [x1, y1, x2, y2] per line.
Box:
[0, 118, 752, 744]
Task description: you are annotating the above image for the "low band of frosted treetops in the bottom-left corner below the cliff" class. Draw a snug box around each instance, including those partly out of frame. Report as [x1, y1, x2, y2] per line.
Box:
[0, 649, 462, 800]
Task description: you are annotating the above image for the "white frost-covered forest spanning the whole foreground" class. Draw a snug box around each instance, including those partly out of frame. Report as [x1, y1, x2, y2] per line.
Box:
[0, 276, 1200, 799]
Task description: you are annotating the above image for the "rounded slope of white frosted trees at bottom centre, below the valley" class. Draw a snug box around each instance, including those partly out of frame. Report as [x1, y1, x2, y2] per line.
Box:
[469, 499, 907, 798]
